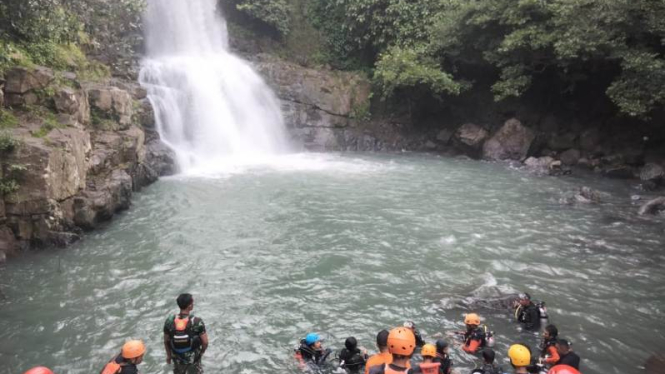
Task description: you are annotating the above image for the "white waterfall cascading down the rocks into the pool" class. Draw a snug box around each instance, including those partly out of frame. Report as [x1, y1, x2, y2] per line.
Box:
[139, 0, 287, 172]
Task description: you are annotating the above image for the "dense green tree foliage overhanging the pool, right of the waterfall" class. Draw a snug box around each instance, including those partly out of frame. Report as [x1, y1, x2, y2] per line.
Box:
[304, 0, 665, 116]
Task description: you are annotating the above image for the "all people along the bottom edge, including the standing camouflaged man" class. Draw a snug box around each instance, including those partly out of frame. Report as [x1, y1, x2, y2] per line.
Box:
[24, 293, 580, 374]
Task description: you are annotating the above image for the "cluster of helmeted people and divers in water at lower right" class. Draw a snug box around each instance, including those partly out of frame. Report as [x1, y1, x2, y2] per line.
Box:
[295, 293, 580, 374]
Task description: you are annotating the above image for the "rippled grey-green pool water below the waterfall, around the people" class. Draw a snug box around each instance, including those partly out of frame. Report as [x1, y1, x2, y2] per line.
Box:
[0, 154, 665, 374]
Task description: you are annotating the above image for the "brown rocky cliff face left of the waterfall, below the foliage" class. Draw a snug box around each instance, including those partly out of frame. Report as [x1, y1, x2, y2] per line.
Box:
[0, 68, 173, 258]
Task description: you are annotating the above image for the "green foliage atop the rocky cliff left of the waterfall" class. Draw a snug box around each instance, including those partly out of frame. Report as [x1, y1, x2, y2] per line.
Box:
[0, 0, 144, 74]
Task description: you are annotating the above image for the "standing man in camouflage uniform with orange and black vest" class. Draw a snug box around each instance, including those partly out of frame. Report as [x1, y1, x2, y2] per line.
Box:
[164, 293, 208, 374]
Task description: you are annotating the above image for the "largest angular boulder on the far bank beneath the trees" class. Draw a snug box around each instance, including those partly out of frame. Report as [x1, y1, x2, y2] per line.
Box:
[483, 118, 536, 161]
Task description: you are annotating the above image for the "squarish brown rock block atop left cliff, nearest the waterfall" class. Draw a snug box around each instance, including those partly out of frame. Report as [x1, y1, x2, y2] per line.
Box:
[87, 87, 134, 130]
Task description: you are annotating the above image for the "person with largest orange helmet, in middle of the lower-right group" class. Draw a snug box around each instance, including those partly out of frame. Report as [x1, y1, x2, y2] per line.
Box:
[369, 327, 416, 374]
